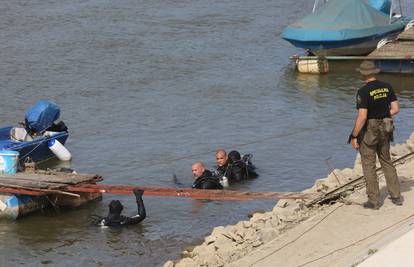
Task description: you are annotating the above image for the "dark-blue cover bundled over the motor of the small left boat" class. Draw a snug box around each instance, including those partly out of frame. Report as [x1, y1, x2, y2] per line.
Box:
[26, 100, 60, 133]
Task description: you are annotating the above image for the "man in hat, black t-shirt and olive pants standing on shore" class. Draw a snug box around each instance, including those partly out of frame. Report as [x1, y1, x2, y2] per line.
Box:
[350, 61, 402, 209]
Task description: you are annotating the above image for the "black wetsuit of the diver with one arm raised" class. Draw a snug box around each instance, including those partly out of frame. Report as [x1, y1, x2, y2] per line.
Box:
[99, 196, 146, 226]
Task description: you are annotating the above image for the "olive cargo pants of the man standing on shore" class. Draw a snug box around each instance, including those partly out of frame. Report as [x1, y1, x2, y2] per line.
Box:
[359, 119, 400, 204]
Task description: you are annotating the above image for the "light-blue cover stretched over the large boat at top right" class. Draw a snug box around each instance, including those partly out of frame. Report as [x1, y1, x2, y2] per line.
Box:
[282, 0, 405, 42]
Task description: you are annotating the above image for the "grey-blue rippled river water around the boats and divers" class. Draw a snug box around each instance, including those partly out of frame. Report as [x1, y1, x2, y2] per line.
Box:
[0, 0, 414, 266]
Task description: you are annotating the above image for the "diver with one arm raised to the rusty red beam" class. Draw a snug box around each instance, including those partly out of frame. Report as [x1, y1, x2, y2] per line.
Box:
[98, 189, 146, 226]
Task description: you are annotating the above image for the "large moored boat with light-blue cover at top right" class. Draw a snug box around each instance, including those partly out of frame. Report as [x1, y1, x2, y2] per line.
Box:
[282, 0, 409, 56]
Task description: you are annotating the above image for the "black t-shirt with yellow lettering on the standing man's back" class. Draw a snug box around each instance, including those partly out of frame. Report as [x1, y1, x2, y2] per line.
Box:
[357, 80, 397, 119]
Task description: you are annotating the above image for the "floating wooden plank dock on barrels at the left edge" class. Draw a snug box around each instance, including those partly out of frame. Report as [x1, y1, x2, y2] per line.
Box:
[0, 171, 102, 219]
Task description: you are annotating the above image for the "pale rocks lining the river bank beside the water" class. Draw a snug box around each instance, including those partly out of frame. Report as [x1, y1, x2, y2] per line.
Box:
[164, 133, 414, 267]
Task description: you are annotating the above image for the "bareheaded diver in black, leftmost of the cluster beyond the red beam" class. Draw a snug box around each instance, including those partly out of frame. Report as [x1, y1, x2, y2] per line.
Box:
[191, 161, 223, 189]
